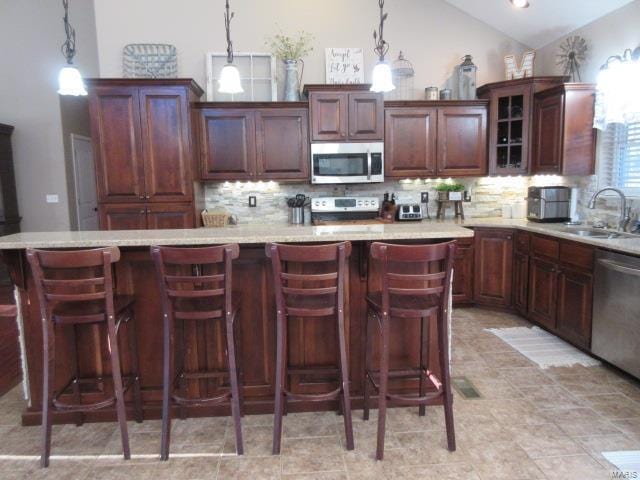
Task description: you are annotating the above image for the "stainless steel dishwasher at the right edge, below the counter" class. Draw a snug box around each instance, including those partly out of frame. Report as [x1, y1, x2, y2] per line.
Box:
[591, 250, 640, 378]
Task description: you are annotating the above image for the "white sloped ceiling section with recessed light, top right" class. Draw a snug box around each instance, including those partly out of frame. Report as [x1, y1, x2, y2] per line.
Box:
[445, 0, 635, 48]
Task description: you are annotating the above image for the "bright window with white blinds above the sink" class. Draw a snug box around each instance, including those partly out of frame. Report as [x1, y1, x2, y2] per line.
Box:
[598, 122, 640, 196]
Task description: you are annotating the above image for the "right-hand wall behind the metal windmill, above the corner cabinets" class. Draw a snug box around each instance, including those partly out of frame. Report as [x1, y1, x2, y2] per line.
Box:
[536, 0, 640, 82]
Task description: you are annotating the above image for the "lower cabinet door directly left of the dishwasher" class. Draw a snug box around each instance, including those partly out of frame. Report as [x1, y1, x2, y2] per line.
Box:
[556, 267, 593, 348]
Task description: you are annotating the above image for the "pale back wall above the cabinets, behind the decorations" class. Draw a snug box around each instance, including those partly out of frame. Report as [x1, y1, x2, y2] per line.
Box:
[95, 0, 525, 98]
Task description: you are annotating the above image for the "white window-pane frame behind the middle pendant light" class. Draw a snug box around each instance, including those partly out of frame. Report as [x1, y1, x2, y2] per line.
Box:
[207, 52, 278, 102]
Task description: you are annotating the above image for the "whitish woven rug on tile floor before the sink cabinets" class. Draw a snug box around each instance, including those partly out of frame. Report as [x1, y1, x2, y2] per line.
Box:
[486, 327, 600, 368]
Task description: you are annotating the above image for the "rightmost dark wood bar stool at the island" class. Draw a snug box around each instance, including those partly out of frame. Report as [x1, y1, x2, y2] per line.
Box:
[363, 242, 456, 460]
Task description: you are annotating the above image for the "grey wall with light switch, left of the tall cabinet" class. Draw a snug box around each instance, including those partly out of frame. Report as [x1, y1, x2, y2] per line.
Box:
[0, 0, 98, 231]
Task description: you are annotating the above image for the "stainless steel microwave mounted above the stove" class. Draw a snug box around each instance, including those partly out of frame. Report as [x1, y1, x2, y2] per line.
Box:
[311, 142, 384, 183]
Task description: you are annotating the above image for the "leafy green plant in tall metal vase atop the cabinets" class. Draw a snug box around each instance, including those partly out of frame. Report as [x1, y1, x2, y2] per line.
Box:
[266, 31, 313, 102]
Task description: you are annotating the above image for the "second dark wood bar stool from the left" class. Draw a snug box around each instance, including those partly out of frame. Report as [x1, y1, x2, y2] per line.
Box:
[151, 244, 244, 460]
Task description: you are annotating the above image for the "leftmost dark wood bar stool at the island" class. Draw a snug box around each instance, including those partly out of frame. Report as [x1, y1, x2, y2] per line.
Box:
[27, 247, 142, 467]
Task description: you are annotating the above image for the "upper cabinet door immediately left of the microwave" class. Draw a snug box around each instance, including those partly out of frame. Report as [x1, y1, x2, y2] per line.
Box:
[256, 108, 309, 180]
